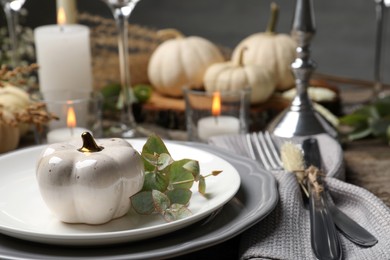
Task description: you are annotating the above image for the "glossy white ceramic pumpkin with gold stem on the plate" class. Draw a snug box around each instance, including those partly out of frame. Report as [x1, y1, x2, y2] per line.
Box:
[36, 132, 145, 224]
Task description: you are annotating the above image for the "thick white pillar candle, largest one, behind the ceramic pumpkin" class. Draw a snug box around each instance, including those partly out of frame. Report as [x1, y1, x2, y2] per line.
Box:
[34, 25, 92, 94]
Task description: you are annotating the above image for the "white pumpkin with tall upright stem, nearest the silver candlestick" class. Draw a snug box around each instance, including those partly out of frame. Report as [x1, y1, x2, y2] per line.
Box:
[232, 3, 297, 90]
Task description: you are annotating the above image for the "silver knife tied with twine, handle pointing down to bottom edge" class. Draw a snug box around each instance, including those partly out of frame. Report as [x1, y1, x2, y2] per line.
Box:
[302, 138, 342, 260]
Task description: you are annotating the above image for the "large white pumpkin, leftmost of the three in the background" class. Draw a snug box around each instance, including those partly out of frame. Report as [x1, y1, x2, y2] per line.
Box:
[148, 29, 224, 97]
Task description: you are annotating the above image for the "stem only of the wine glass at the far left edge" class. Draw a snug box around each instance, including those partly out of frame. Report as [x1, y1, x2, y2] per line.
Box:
[4, 3, 19, 67]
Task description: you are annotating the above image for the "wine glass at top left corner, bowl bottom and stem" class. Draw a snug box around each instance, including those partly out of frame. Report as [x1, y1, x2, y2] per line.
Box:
[0, 0, 26, 67]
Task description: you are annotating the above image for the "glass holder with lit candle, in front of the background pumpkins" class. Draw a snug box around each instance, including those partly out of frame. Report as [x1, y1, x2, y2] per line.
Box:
[184, 88, 250, 142]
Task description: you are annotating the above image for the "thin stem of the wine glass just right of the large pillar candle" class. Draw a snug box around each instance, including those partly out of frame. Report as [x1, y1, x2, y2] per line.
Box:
[113, 6, 135, 129]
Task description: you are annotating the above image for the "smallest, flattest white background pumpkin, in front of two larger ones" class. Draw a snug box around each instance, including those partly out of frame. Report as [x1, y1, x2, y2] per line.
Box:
[204, 48, 275, 104]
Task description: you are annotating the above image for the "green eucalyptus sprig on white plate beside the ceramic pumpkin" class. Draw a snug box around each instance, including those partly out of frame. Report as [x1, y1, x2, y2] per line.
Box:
[131, 135, 222, 222]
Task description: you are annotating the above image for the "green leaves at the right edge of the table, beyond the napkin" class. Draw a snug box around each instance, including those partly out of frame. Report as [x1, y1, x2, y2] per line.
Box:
[339, 97, 390, 141]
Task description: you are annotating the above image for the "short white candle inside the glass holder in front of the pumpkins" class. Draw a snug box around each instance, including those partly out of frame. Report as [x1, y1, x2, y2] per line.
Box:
[198, 116, 240, 141]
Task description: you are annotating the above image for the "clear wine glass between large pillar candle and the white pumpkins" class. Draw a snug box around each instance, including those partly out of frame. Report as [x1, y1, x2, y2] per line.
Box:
[103, 0, 140, 138]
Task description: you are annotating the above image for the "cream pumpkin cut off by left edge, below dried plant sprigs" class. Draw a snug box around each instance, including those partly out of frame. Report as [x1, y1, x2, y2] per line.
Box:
[0, 107, 20, 153]
